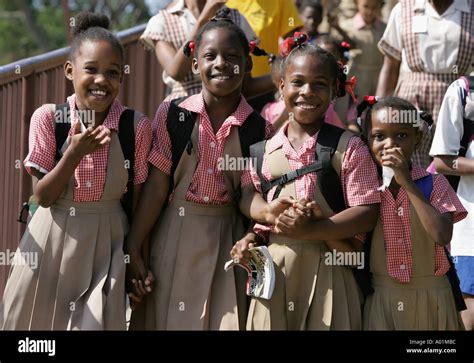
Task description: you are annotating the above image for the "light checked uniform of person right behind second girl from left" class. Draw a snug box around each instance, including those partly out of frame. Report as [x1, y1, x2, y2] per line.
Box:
[140, 0, 257, 101]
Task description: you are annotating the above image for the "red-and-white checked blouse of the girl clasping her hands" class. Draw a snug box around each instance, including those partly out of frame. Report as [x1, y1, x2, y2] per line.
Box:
[242, 123, 380, 238]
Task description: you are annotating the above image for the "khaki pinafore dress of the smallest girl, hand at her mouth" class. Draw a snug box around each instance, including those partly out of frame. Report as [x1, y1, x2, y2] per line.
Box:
[363, 190, 464, 330]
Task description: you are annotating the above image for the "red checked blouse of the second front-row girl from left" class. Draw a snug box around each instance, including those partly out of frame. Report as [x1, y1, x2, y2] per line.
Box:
[148, 93, 273, 205]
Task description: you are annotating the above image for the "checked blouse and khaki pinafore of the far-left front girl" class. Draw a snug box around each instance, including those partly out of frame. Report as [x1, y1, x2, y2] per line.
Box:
[2, 95, 151, 330]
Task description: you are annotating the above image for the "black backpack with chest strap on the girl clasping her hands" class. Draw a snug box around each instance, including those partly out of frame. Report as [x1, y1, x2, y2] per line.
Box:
[250, 123, 373, 296]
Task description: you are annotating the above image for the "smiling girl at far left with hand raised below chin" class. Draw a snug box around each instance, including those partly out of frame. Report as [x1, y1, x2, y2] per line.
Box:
[2, 13, 151, 330]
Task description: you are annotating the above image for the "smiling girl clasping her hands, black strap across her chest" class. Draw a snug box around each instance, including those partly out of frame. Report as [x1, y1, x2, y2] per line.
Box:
[231, 34, 380, 330]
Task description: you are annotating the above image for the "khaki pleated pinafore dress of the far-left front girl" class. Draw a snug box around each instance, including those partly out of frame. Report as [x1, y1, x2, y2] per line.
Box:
[1, 125, 128, 330]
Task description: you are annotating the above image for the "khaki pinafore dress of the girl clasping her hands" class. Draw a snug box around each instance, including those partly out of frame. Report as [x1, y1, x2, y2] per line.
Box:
[247, 132, 363, 330]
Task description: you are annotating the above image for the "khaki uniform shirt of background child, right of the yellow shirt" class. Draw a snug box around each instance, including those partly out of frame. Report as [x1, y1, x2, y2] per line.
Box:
[341, 13, 387, 99]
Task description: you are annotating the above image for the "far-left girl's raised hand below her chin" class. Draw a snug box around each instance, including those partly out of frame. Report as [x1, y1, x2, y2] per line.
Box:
[68, 122, 110, 158]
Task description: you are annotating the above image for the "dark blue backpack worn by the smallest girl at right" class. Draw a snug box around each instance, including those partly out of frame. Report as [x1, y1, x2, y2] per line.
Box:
[364, 174, 466, 311]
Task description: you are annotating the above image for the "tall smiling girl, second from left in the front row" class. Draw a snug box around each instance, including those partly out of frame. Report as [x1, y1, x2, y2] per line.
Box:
[126, 13, 271, 330]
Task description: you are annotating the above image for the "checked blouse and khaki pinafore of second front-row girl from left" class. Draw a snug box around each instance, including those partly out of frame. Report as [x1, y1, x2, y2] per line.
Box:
[130, 93, 271, 330]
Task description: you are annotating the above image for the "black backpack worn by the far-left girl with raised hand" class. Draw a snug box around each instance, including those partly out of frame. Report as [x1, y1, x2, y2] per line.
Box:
[17, 102, 143, 224]
